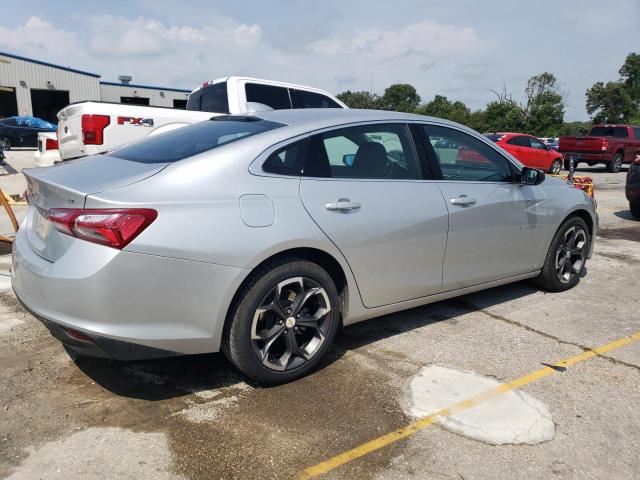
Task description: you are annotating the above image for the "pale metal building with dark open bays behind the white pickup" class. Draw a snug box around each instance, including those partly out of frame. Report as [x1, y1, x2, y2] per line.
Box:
[0, 52, 190, 123]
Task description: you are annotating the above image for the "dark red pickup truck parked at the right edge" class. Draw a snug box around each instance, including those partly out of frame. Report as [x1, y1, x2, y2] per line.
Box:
[558, 125, 640, 173]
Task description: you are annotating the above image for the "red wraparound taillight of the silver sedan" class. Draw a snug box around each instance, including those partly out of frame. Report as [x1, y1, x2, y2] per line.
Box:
[48, 208, 158, 250]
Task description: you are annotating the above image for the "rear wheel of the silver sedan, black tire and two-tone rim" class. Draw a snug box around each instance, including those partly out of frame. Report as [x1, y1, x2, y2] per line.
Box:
[222, 258, 340, 385]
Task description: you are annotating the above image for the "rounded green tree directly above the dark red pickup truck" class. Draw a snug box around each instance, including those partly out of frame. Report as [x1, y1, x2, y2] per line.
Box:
[587, 82, 638, 123]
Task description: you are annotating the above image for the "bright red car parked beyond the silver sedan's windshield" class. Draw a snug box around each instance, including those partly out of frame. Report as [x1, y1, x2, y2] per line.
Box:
[486, 132, 564, 175]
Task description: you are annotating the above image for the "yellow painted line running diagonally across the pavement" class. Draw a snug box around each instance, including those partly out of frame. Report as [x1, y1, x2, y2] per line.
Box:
[298, 332, 640, 480]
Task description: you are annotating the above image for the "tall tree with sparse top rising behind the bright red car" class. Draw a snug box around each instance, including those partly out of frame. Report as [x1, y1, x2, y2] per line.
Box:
[522, 72, 564, 136]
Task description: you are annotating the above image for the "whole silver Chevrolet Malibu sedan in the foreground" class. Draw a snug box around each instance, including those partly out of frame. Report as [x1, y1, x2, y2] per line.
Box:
[12, 109, 597, 384]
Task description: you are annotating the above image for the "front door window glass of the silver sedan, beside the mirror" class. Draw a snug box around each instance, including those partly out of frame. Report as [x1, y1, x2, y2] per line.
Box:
[424, 125, 512, 182]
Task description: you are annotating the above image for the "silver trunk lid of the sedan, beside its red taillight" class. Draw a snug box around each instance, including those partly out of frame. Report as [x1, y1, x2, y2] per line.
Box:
[23, 155, 167, 262]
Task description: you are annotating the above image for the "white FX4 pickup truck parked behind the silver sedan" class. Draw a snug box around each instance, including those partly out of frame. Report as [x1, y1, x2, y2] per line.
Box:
[58, 77, 347, 160]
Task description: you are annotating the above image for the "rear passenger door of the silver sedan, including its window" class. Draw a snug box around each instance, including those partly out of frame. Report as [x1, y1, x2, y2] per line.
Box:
[300, 123, 448, 307]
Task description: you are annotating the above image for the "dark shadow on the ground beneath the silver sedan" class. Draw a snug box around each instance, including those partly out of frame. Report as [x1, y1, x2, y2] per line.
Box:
[70, 282, 537, 401]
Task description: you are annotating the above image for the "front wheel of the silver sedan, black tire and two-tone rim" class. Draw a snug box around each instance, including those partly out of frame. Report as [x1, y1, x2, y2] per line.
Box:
[532, 217, 591, 292]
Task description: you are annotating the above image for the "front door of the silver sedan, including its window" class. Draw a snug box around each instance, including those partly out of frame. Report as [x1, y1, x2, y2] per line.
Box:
[422, 125, 545, 290]
